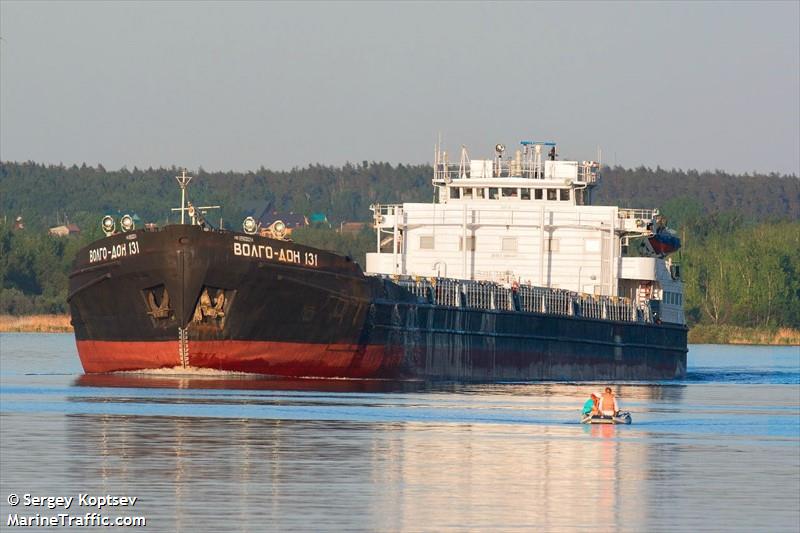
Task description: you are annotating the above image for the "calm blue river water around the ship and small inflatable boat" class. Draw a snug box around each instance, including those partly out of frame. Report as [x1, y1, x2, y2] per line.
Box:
[0, 334, 800, 533]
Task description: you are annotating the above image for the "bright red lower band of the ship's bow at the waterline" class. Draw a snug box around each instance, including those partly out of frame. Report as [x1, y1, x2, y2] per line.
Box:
[77, 340, 402, 378]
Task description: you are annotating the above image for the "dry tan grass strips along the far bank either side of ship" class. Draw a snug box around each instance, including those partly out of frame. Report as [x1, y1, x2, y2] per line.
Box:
[0, 315, 800, 346]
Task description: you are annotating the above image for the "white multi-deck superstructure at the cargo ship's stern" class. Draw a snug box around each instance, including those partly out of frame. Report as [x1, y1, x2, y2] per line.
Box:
[367, 141, 684, 324]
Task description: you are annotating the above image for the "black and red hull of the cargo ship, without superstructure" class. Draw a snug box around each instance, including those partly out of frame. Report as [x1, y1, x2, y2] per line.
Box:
[69, 225, 687, 381]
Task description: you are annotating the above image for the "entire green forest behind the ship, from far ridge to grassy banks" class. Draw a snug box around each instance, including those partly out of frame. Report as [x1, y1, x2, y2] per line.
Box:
[0, 161, 800, 328]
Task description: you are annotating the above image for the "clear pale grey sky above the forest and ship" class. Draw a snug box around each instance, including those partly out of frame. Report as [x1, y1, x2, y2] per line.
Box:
[0, 0, 800, 175]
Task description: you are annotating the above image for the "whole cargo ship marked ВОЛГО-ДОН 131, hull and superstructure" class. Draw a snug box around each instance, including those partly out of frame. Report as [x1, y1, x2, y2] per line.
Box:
[68, 141, 687, 381]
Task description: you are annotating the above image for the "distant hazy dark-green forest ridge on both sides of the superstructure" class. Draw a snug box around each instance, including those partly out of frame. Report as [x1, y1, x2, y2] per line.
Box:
[0, 161, 800, 229]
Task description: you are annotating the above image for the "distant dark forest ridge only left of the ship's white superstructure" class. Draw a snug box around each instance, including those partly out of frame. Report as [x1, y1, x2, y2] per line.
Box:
[0, 161, 432, 229]
